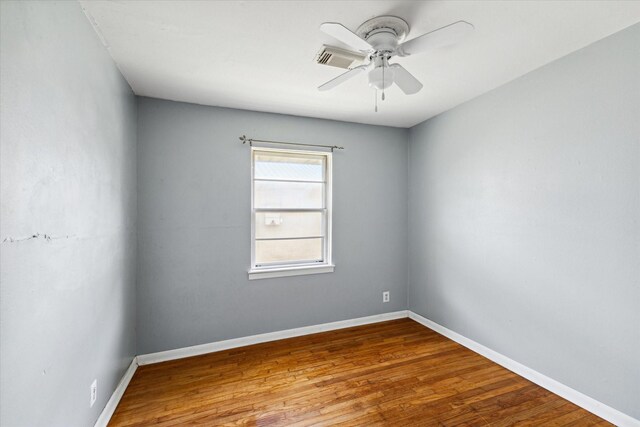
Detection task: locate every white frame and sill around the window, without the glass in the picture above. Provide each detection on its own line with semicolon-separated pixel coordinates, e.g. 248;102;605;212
249;147;335;280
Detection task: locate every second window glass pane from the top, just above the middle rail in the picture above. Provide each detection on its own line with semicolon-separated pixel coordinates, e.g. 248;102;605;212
253;181;324;209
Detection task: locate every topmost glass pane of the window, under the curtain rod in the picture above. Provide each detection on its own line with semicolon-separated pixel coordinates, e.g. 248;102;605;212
253;151;324;182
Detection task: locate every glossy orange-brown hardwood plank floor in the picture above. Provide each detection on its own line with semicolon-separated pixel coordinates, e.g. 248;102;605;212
109;319;611;426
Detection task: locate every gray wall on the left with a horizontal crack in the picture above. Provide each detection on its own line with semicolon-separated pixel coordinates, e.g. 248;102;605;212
0;1;136;427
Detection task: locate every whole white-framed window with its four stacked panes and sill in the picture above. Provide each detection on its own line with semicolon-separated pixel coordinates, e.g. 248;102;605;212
249;147;333;279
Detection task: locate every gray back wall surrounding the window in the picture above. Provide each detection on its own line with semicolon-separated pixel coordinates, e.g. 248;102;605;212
137;98;407;354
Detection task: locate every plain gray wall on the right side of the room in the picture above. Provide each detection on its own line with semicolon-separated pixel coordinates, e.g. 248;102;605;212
409;25;640;418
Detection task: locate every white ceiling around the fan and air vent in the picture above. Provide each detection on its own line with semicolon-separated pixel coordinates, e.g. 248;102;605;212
81;0;640;127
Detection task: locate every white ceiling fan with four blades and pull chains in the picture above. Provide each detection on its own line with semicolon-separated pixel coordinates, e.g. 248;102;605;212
318;16;473;100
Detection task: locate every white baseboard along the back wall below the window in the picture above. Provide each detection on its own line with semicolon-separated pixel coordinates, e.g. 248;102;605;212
138;310;409;365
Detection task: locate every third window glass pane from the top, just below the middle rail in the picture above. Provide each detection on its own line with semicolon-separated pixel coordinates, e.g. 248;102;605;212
255;212;324;239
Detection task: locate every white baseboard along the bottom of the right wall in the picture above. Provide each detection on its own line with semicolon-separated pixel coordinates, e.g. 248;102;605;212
409;311;640;427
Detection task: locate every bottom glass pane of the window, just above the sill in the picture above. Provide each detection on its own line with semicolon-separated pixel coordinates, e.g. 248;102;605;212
256;239;323;265
